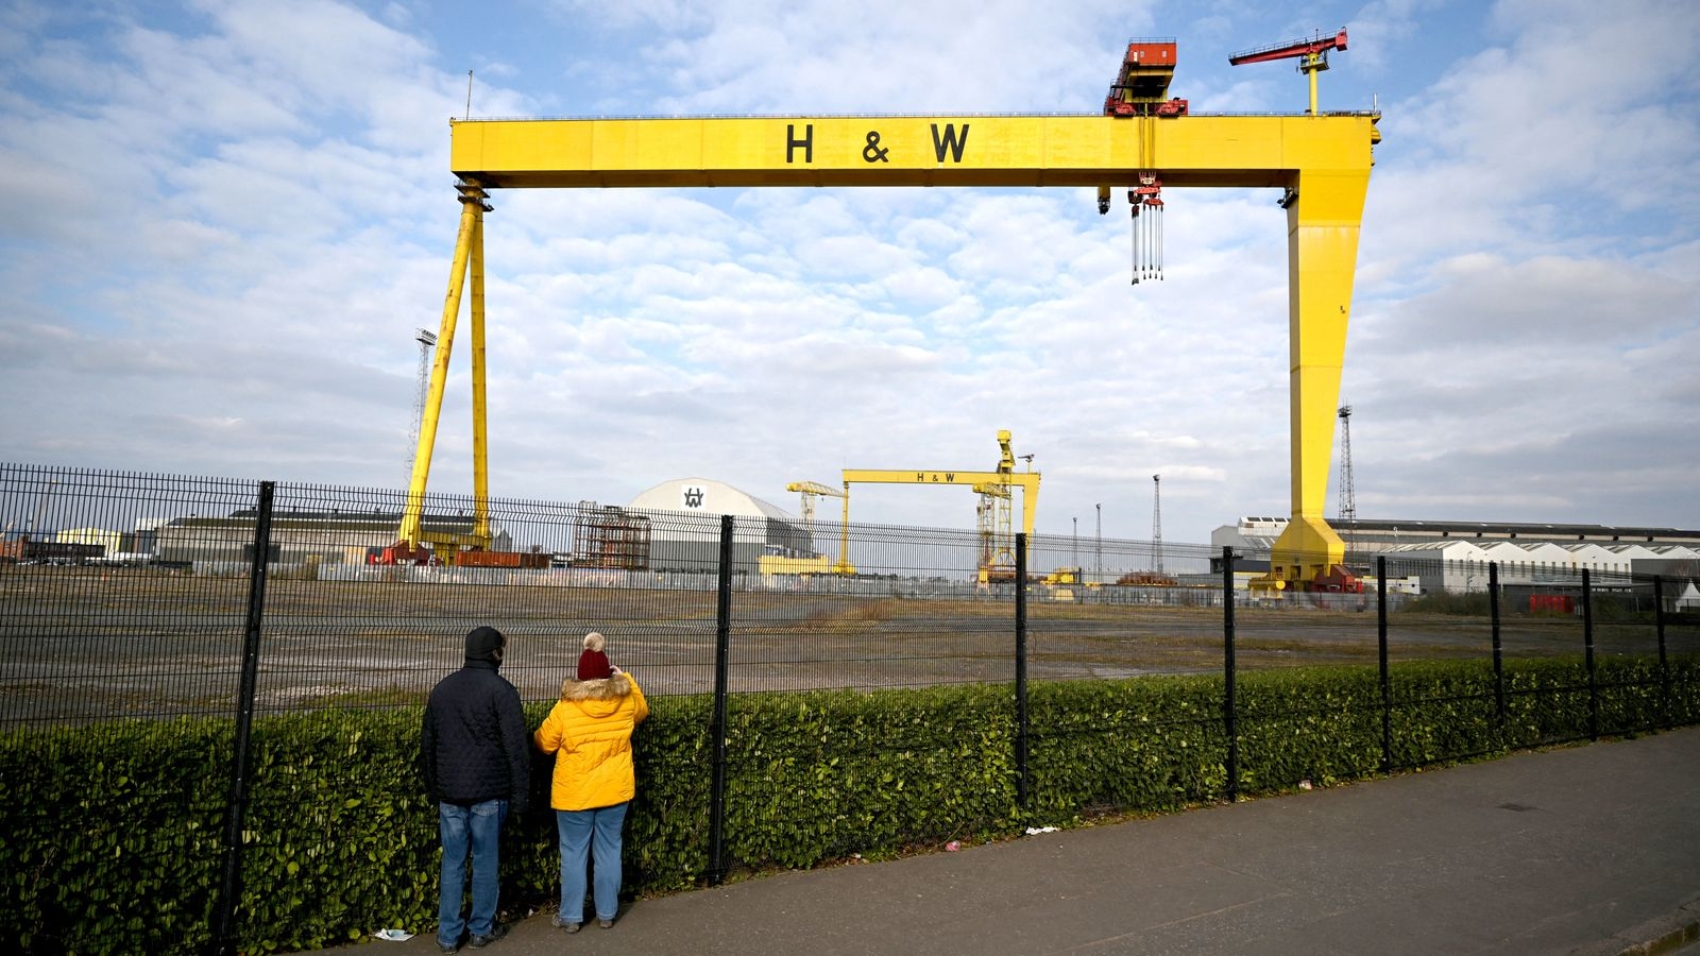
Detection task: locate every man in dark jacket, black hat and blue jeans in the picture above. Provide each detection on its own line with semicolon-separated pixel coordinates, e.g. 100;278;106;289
420;628;530;953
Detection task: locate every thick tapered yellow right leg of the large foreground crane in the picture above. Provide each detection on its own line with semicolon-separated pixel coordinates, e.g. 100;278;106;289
1256;168;1370;587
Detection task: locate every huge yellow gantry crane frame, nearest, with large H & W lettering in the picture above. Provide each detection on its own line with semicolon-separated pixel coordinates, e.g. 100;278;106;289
421;35;1380;587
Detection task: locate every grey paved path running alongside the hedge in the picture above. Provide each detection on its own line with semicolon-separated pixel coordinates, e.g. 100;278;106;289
348;728;1700;956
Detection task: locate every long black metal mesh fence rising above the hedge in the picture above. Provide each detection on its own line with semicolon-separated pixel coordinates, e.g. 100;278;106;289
0;466;1700;939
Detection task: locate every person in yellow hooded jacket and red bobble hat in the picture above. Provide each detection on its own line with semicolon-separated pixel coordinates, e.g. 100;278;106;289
534;631;649;932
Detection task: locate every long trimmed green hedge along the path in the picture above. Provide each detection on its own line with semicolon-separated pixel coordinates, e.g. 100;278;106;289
0;655;1700;953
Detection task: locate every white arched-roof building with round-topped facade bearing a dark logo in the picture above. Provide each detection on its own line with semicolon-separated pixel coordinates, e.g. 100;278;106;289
627;478;814;573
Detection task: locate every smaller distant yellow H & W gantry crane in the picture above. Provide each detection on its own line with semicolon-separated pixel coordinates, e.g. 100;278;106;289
833;429;1039;583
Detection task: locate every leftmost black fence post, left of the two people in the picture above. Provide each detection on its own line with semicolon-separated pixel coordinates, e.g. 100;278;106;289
213;481;277;953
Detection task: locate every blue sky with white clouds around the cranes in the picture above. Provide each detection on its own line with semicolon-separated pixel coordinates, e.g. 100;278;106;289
0;0;1700;541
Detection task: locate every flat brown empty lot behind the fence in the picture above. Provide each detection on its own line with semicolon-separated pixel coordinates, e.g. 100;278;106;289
0;566;1700;714
